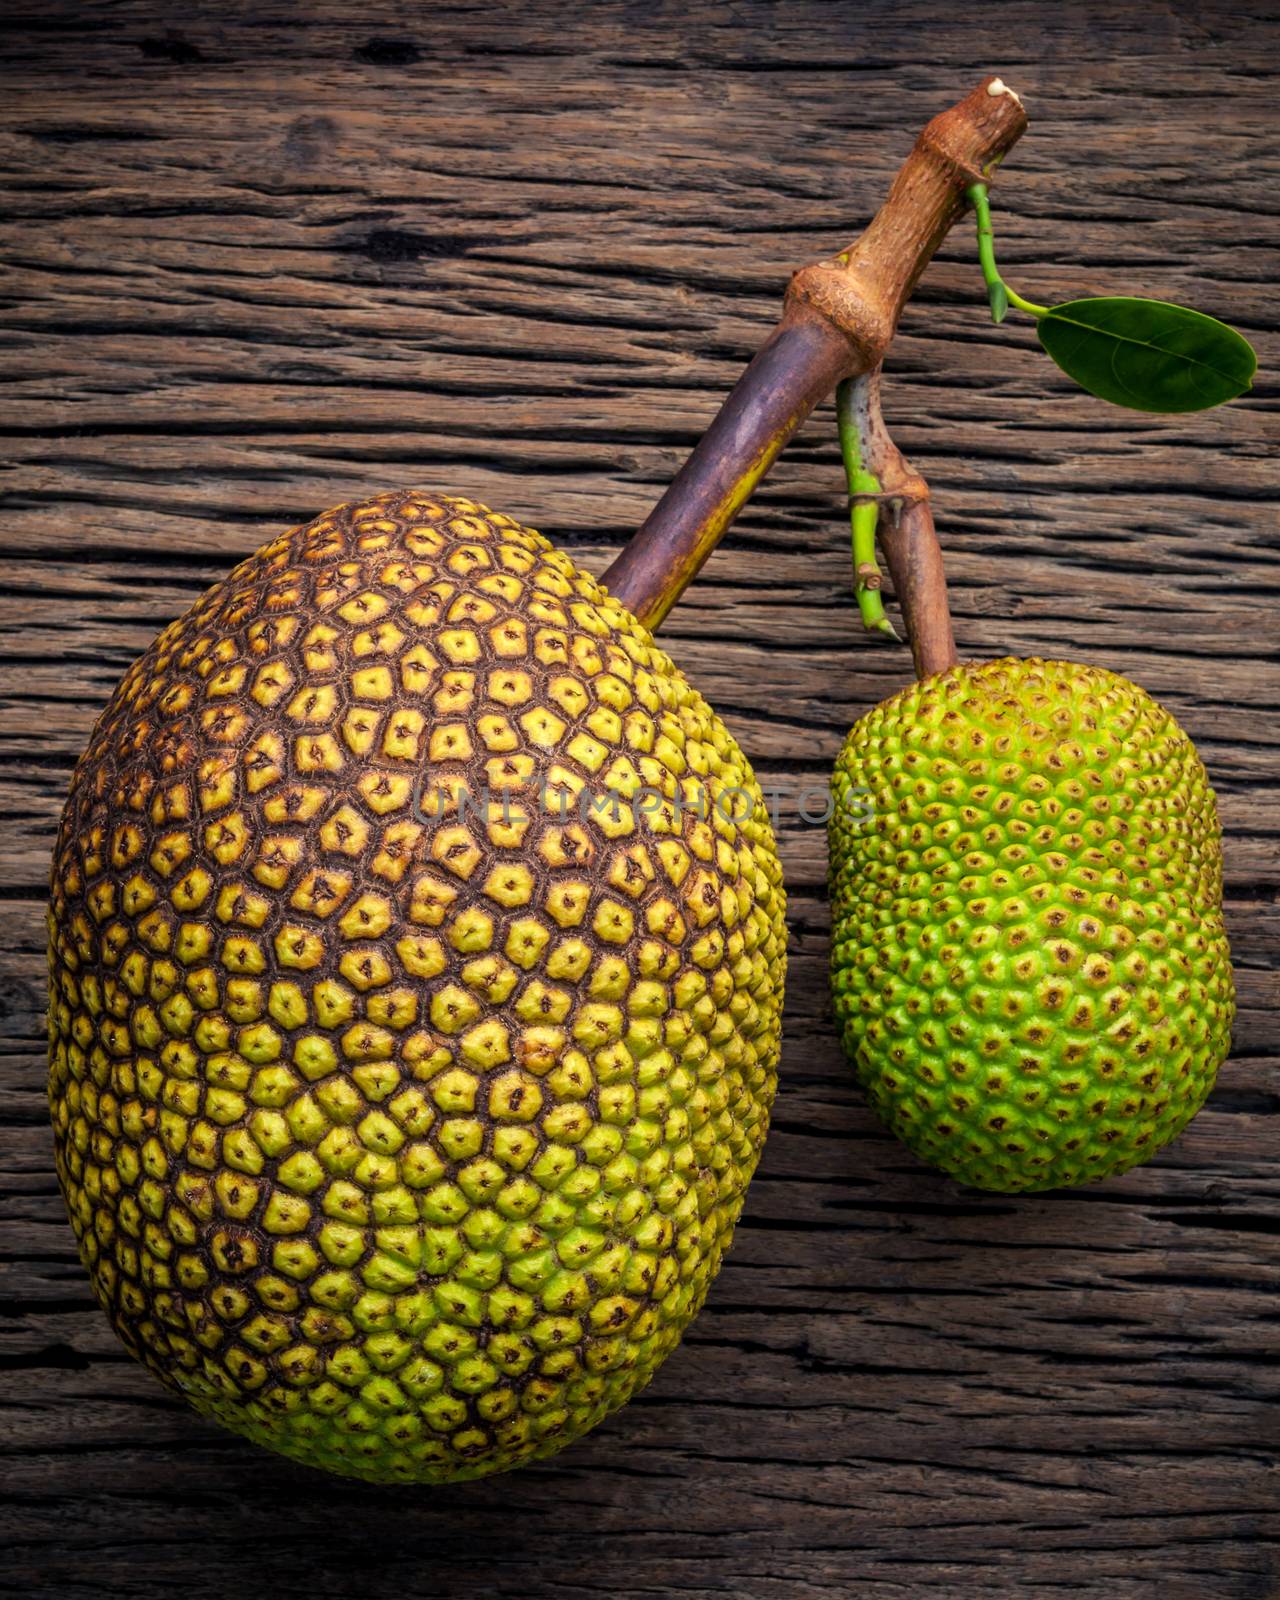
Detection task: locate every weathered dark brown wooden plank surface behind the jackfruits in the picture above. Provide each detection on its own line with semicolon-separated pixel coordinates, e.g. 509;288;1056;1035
0;0;1280;1600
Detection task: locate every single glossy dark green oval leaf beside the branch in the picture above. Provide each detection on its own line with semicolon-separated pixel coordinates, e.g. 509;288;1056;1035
1035;296;1258;411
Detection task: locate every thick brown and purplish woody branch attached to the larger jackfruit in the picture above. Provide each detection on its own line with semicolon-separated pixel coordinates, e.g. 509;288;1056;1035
603;78;1027;627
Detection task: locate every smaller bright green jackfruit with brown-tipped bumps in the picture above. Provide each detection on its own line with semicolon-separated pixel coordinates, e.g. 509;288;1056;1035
830;659;1235;1192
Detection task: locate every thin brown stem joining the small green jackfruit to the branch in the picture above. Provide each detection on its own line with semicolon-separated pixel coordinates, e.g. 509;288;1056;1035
840;366;957;678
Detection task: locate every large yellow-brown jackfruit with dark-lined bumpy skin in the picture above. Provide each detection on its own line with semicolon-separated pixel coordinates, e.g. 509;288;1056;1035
50;491;786;1482
